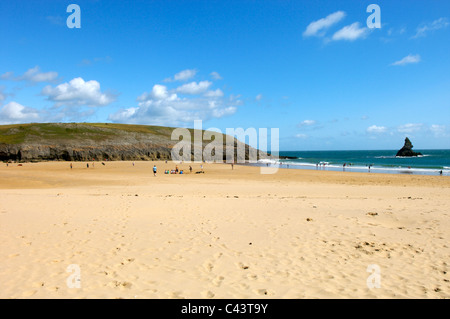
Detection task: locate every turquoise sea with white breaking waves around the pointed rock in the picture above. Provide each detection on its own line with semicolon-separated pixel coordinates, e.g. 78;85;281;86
258;150;450;176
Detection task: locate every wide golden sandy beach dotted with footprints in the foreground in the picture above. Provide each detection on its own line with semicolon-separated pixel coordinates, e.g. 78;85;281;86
0;162;450;299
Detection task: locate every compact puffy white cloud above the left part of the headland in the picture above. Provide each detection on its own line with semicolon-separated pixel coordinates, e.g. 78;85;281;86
41;78;115;106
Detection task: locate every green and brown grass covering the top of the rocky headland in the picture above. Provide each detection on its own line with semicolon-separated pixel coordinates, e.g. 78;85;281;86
0;123;187;145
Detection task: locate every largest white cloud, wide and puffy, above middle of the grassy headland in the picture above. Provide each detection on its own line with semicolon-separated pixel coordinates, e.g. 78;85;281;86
108;81;242;126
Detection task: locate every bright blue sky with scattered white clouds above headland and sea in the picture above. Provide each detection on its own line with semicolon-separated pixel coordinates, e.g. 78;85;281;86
0;0;450;150
